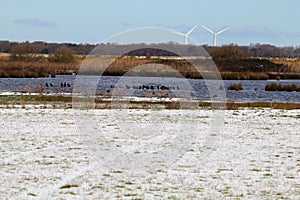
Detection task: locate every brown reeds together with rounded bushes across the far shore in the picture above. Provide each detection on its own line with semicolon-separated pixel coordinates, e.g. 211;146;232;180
0;43;300;80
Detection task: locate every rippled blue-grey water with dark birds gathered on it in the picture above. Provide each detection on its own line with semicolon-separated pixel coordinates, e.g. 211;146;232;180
0;76;300;102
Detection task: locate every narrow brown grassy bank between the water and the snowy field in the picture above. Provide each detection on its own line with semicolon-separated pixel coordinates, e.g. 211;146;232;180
0;95;300;110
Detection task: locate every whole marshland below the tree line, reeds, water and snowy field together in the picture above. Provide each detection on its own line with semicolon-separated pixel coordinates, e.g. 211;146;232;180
0;43;300;199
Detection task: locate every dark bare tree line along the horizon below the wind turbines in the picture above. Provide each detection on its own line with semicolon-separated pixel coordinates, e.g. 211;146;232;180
0;41;300;58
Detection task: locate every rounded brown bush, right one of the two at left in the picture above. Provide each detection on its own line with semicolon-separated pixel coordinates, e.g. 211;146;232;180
49;46;76;63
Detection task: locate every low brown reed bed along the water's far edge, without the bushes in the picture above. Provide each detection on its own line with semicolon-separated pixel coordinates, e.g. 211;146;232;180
0;56;300;80
